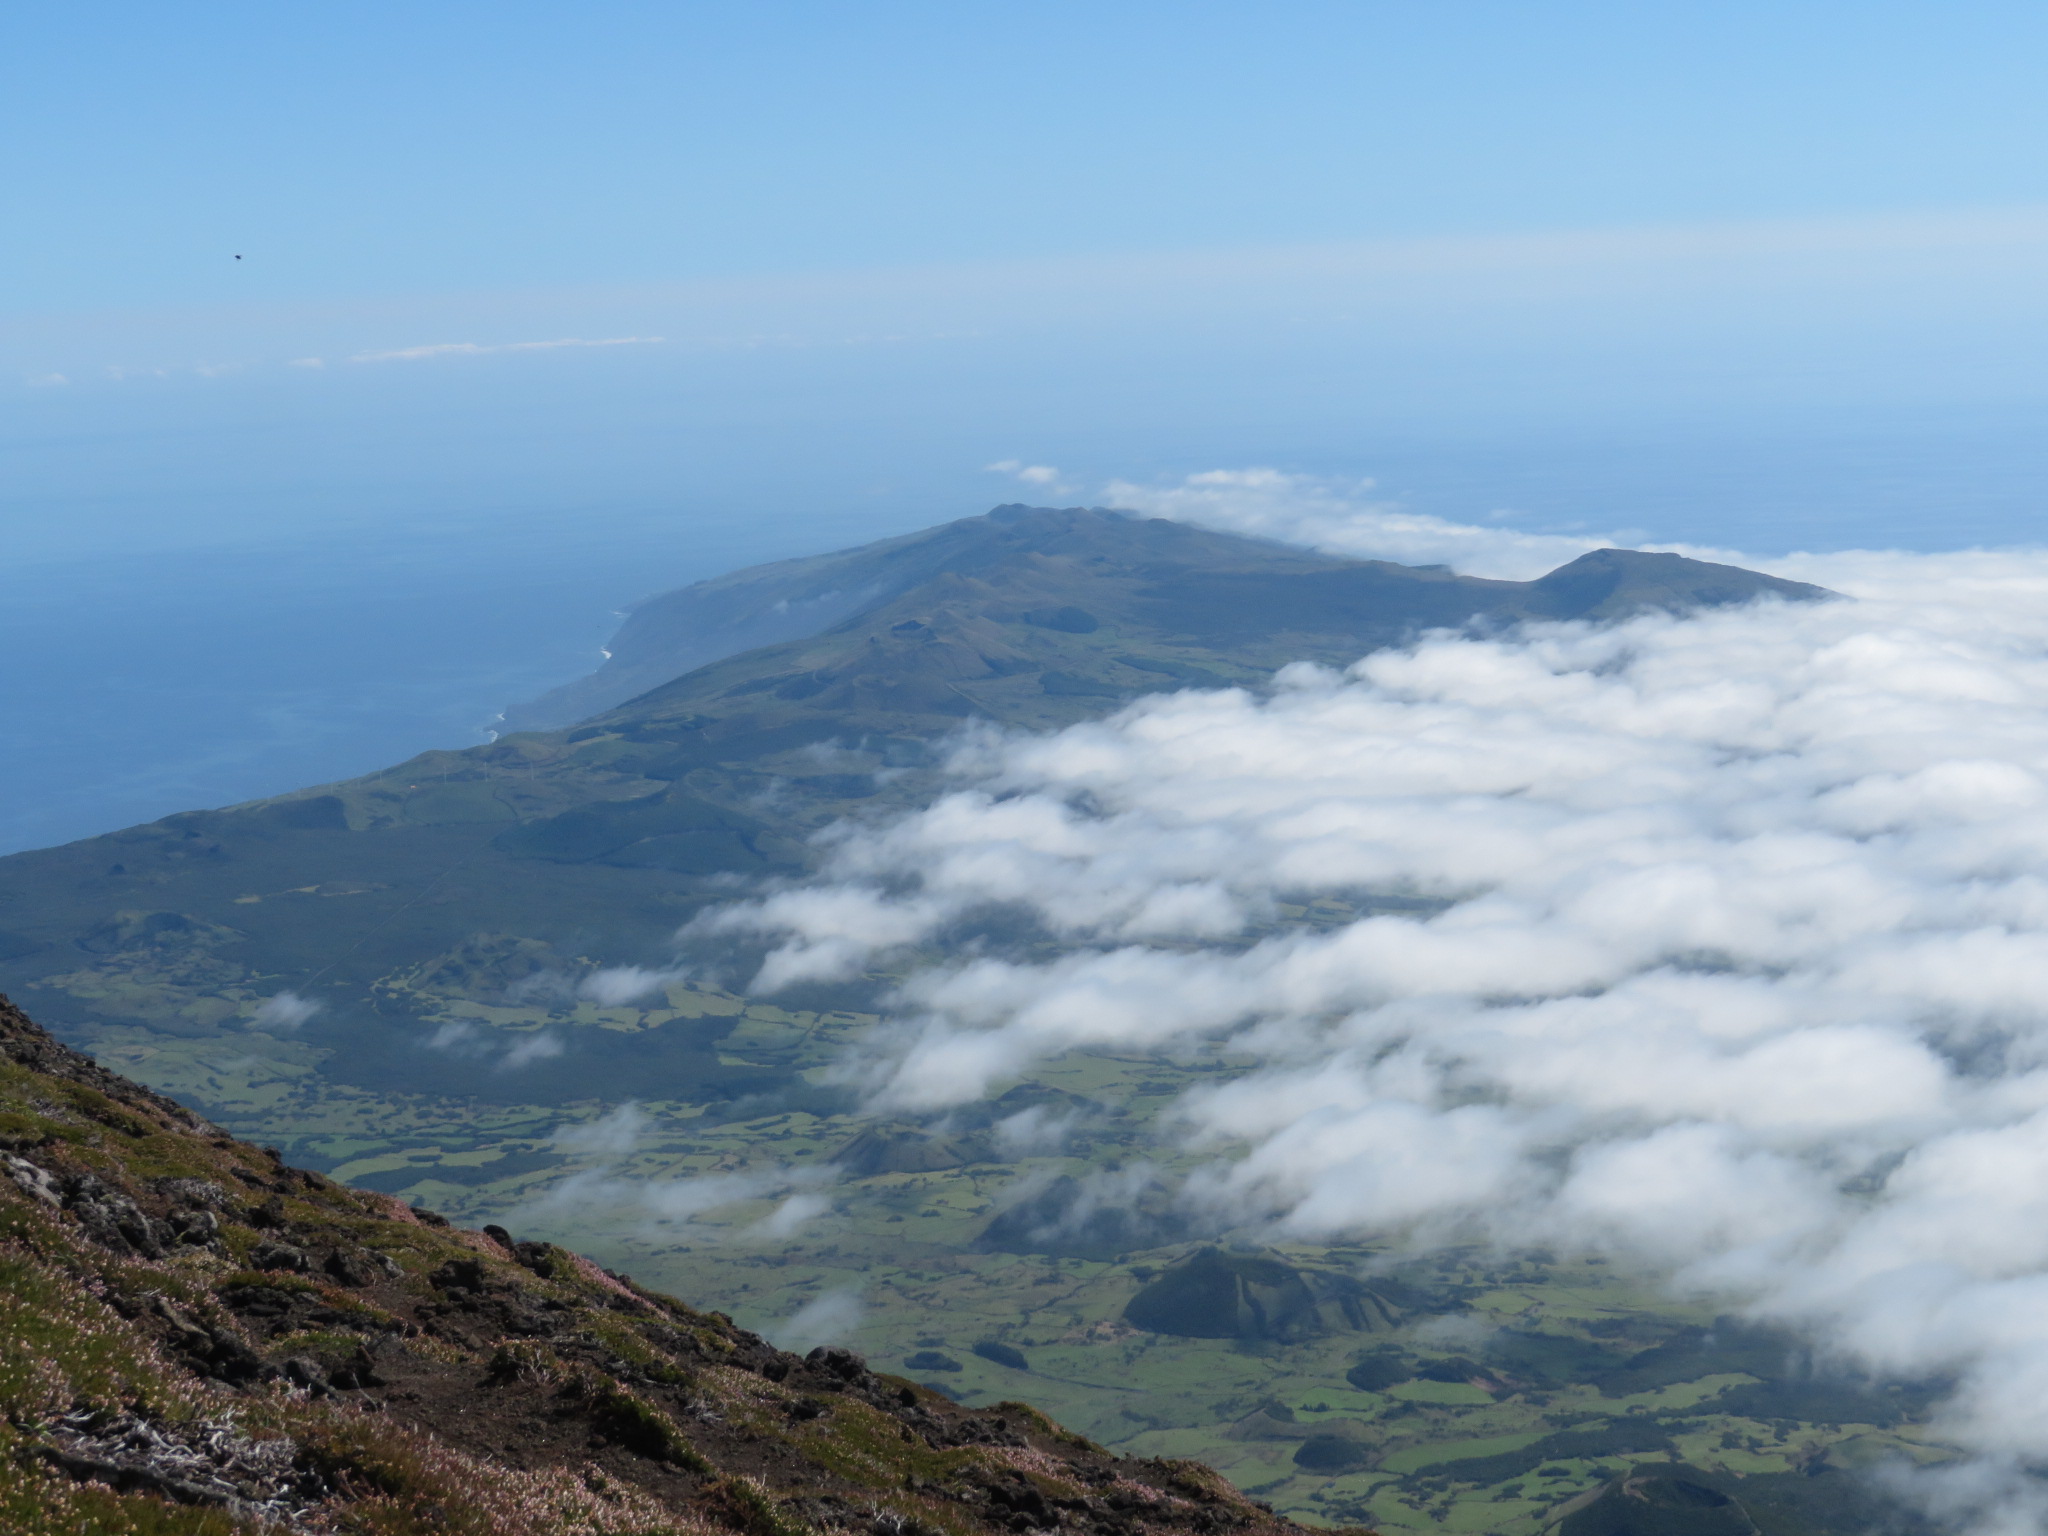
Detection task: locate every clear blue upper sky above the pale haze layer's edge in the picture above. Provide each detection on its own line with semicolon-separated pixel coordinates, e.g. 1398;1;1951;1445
12;0;2048;309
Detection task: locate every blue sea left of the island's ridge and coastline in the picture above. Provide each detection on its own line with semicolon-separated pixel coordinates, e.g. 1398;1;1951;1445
0;518;872;852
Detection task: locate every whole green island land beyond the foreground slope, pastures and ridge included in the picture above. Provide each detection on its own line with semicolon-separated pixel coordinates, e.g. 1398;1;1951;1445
0;508;1884;1536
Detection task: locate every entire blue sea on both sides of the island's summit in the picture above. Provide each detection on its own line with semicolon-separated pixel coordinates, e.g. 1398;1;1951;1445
0;410;2048;850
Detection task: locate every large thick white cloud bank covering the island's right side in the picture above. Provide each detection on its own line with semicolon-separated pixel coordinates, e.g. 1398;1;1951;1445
713;499;2048;1530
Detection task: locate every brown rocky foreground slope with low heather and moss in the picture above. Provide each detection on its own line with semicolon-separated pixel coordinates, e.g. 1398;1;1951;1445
0;997;1300;1536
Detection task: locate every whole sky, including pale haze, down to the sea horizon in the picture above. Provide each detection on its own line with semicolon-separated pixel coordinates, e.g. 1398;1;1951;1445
16;0;2048;493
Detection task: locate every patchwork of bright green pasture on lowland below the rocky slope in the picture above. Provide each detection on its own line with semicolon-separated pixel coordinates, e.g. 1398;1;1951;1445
51;966;1948;1536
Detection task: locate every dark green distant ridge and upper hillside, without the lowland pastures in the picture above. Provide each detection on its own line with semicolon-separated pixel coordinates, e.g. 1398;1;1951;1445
0;508;1819;1081
